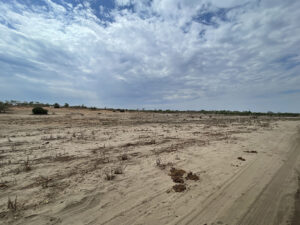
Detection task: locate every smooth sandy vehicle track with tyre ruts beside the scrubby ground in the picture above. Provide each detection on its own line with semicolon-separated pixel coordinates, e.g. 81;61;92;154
175;126;300;225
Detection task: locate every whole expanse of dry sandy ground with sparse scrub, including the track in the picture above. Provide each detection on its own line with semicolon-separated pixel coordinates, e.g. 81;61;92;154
0;108;300;225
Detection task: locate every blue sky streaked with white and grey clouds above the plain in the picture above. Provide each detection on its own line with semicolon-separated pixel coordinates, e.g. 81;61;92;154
0;0;300;112
